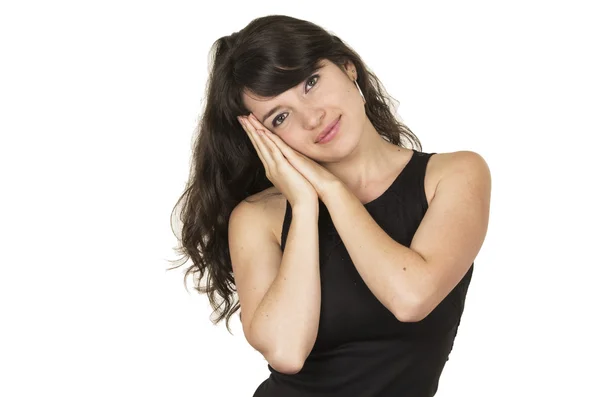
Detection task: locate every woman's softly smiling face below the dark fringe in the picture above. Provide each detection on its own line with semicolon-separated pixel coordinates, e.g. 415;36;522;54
243;60;366;159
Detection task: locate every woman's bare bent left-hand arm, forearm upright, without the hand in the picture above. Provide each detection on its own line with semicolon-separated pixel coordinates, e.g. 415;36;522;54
230;203;321;374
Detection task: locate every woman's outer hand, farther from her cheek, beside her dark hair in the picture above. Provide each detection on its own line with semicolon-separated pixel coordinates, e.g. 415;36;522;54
238;116;318;207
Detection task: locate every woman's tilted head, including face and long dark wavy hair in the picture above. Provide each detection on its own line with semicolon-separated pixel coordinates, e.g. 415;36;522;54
169;15;421;329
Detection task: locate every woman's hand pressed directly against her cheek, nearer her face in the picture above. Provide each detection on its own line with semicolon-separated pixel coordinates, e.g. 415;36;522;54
239;114;339;198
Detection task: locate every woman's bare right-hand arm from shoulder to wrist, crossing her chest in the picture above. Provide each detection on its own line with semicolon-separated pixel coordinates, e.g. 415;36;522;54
323;151;491;322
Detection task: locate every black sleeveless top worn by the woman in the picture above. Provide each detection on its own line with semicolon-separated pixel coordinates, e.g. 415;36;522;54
253;149;474;397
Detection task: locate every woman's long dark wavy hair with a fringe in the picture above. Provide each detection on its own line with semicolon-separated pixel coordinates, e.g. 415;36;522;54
169;15;422;333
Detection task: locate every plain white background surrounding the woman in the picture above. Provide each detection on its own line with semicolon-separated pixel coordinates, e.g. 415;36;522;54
0;1;600;397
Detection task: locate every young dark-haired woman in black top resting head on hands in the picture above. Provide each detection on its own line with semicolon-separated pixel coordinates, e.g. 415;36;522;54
171;16;491;397
